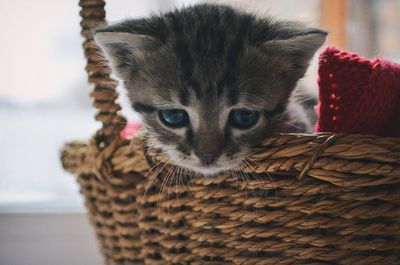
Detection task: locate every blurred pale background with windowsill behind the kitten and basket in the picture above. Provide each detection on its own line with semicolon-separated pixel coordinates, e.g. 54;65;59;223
0;0;400;265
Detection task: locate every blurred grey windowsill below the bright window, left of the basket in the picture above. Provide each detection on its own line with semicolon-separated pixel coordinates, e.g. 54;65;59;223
0;213;102;265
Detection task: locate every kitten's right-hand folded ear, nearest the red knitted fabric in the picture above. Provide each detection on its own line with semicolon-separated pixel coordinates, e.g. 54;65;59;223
261;27;328;72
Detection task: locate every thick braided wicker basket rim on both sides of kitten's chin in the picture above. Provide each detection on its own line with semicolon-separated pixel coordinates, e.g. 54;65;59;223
61;132;400;187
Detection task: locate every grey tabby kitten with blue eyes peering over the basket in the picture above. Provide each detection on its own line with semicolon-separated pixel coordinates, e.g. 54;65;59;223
95;4;327;175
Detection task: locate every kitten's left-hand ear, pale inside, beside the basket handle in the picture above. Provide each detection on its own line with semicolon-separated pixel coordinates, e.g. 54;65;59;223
94;25;162;79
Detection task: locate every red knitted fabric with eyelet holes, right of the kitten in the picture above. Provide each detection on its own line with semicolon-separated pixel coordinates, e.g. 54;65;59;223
316;47;400;137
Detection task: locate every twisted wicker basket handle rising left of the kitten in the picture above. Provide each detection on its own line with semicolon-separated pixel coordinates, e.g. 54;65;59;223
79;0;126;146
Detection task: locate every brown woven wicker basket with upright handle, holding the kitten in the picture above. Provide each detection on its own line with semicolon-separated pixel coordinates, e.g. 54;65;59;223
62;0;400;264
